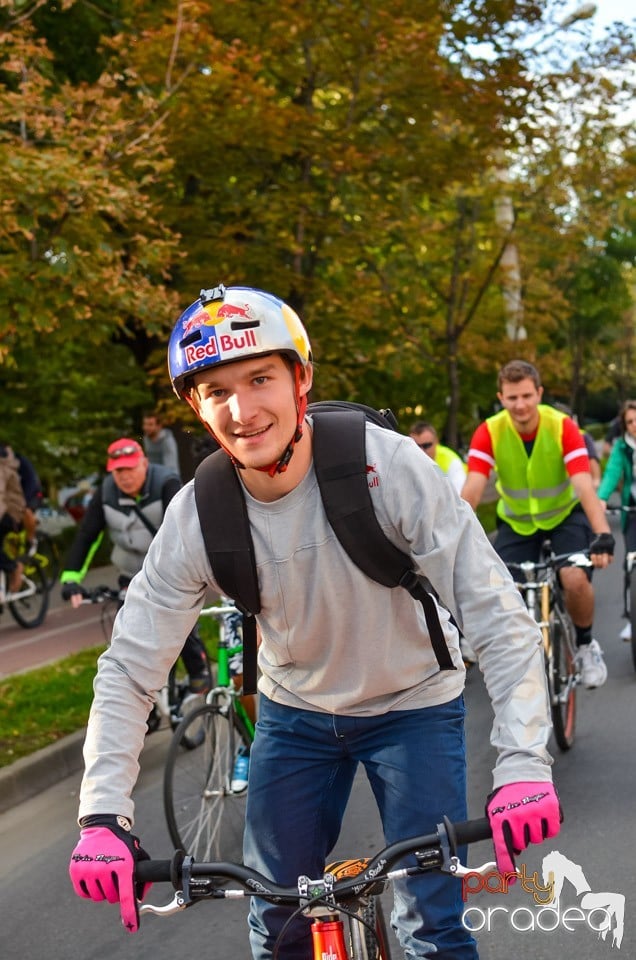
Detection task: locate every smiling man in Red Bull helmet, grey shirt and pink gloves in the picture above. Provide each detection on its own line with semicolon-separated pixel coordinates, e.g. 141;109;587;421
70;287;560;960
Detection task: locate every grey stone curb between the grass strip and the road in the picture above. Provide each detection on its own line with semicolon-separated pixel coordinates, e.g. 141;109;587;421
0;728;86;813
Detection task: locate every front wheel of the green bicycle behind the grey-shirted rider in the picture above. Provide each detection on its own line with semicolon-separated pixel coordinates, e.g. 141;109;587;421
163;703;251;861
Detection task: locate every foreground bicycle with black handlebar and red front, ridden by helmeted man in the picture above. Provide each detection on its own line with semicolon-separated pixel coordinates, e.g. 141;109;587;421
136;817;496;960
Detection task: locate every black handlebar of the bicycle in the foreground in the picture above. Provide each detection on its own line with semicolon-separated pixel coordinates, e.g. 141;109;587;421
135;817;492;903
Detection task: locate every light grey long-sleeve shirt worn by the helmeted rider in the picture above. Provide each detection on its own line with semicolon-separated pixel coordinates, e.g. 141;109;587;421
80;425;551;818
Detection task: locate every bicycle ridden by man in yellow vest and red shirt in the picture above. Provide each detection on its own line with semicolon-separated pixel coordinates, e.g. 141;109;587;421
507;540;593;751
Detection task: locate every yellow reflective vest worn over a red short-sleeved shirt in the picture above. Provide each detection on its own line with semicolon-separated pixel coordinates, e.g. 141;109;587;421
486;404;579;536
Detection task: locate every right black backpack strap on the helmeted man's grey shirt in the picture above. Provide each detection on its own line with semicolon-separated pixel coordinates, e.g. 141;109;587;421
312;409;456;670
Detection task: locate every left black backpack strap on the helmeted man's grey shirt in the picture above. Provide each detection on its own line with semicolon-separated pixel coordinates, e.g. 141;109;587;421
194;450;261;693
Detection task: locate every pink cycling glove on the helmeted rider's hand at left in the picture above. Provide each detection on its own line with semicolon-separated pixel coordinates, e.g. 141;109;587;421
69;814;150;933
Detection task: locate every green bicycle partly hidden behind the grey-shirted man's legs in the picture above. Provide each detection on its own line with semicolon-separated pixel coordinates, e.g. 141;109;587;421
163;598;254;860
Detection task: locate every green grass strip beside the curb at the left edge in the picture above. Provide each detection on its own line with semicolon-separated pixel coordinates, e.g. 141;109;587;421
0;646;104;767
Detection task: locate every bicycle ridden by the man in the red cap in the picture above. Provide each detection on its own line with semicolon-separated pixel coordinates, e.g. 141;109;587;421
80;585;210;750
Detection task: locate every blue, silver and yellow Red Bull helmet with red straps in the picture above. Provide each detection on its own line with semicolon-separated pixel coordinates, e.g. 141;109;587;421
168;284;311;399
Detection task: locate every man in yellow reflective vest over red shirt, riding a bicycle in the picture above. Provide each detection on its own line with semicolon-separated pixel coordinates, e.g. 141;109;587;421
462;360;614;689
